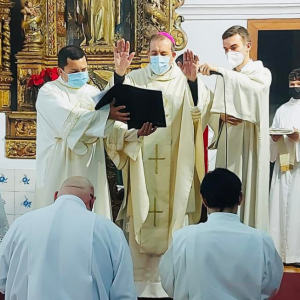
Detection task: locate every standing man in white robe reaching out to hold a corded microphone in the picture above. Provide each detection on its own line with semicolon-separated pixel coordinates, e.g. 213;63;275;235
199;26;272;231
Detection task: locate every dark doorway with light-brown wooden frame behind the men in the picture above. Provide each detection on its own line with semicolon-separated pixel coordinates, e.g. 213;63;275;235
248;19;300;125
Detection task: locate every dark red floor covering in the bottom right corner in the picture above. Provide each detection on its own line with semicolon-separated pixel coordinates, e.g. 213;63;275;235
272;273;300;300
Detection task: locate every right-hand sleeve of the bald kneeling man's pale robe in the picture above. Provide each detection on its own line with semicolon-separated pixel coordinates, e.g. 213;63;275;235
110;230;137;300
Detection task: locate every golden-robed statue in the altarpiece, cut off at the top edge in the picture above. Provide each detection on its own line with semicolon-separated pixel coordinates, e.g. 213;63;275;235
74;0;120;46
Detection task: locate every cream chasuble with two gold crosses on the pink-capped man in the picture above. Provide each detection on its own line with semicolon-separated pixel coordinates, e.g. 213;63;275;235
105;64;204;297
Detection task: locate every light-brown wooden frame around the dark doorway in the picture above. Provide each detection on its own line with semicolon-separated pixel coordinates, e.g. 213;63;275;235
248;19;300;60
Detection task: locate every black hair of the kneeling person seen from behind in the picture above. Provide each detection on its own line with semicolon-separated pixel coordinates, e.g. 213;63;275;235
200;168;242;211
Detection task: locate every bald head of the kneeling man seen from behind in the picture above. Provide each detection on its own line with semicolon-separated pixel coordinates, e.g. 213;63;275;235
54;176;96;210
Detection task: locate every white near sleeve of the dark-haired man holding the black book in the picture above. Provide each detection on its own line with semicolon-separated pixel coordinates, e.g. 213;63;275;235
36;84;114;150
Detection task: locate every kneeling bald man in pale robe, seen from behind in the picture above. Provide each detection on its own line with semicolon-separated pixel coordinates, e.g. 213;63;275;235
0;177;136;300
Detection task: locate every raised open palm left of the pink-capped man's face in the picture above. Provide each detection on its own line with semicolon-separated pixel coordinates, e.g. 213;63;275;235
114;39;135;76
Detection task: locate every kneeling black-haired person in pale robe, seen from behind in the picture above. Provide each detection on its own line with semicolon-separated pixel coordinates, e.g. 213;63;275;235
159;169;283;300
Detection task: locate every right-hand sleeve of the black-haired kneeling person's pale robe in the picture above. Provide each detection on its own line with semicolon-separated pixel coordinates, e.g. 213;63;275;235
261;234;283;299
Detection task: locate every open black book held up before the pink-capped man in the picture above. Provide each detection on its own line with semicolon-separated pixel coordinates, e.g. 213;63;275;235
93;84;166;129
